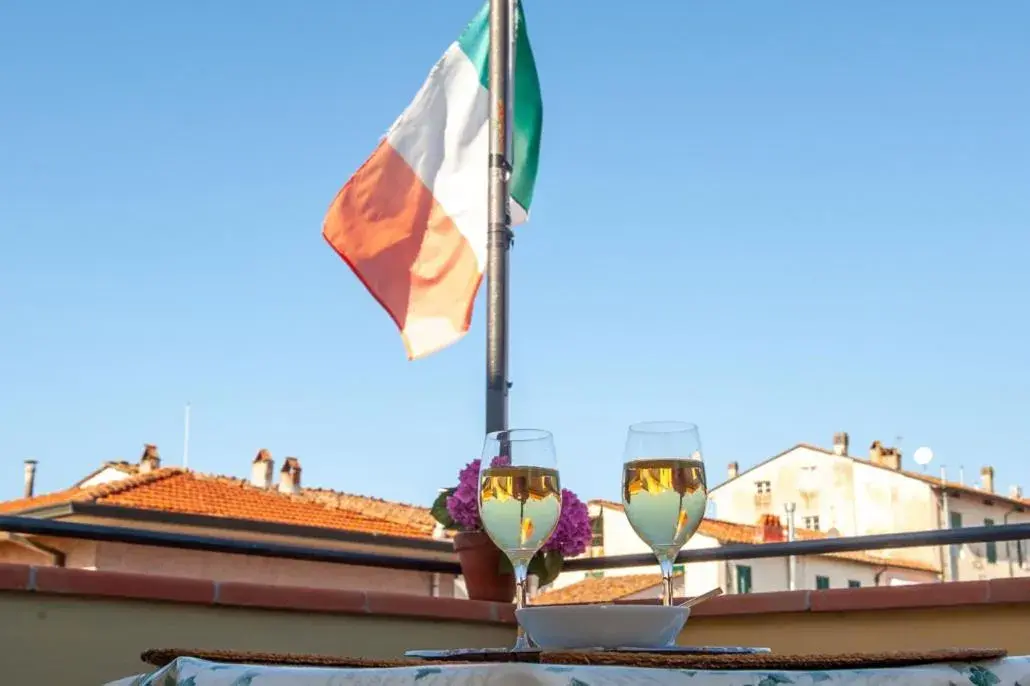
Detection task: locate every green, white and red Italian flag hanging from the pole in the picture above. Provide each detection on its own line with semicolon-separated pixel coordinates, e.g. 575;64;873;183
322;2;543;359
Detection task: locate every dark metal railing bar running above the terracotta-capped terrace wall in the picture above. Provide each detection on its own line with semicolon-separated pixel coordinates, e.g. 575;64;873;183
6;516;1030;575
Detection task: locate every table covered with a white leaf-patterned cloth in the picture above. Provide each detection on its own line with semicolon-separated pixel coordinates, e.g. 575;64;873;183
108;656;1030;686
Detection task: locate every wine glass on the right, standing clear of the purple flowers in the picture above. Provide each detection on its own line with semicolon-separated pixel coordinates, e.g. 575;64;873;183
622;421;708;605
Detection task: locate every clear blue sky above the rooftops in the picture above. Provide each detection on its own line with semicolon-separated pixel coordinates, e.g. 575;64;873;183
0;0;1030;503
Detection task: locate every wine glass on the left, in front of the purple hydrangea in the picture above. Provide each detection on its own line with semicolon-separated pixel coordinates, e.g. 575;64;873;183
479;428;561;650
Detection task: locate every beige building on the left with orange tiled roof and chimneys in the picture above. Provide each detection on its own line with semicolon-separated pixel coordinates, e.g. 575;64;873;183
0;446;460;596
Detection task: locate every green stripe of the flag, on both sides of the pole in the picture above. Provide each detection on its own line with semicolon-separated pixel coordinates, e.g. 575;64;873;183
457;2;544;212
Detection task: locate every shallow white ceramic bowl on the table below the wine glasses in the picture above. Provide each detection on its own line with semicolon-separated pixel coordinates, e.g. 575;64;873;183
515;605;690;650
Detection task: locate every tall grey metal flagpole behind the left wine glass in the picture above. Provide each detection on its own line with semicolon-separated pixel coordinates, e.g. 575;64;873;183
486;0;516;433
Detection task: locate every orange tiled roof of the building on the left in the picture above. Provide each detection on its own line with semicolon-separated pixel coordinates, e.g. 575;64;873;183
0;468;433;539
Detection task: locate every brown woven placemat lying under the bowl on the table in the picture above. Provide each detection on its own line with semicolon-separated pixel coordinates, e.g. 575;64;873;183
140;648;1008;672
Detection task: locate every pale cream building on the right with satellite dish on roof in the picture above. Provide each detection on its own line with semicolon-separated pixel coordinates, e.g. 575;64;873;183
710;433;1030;581
